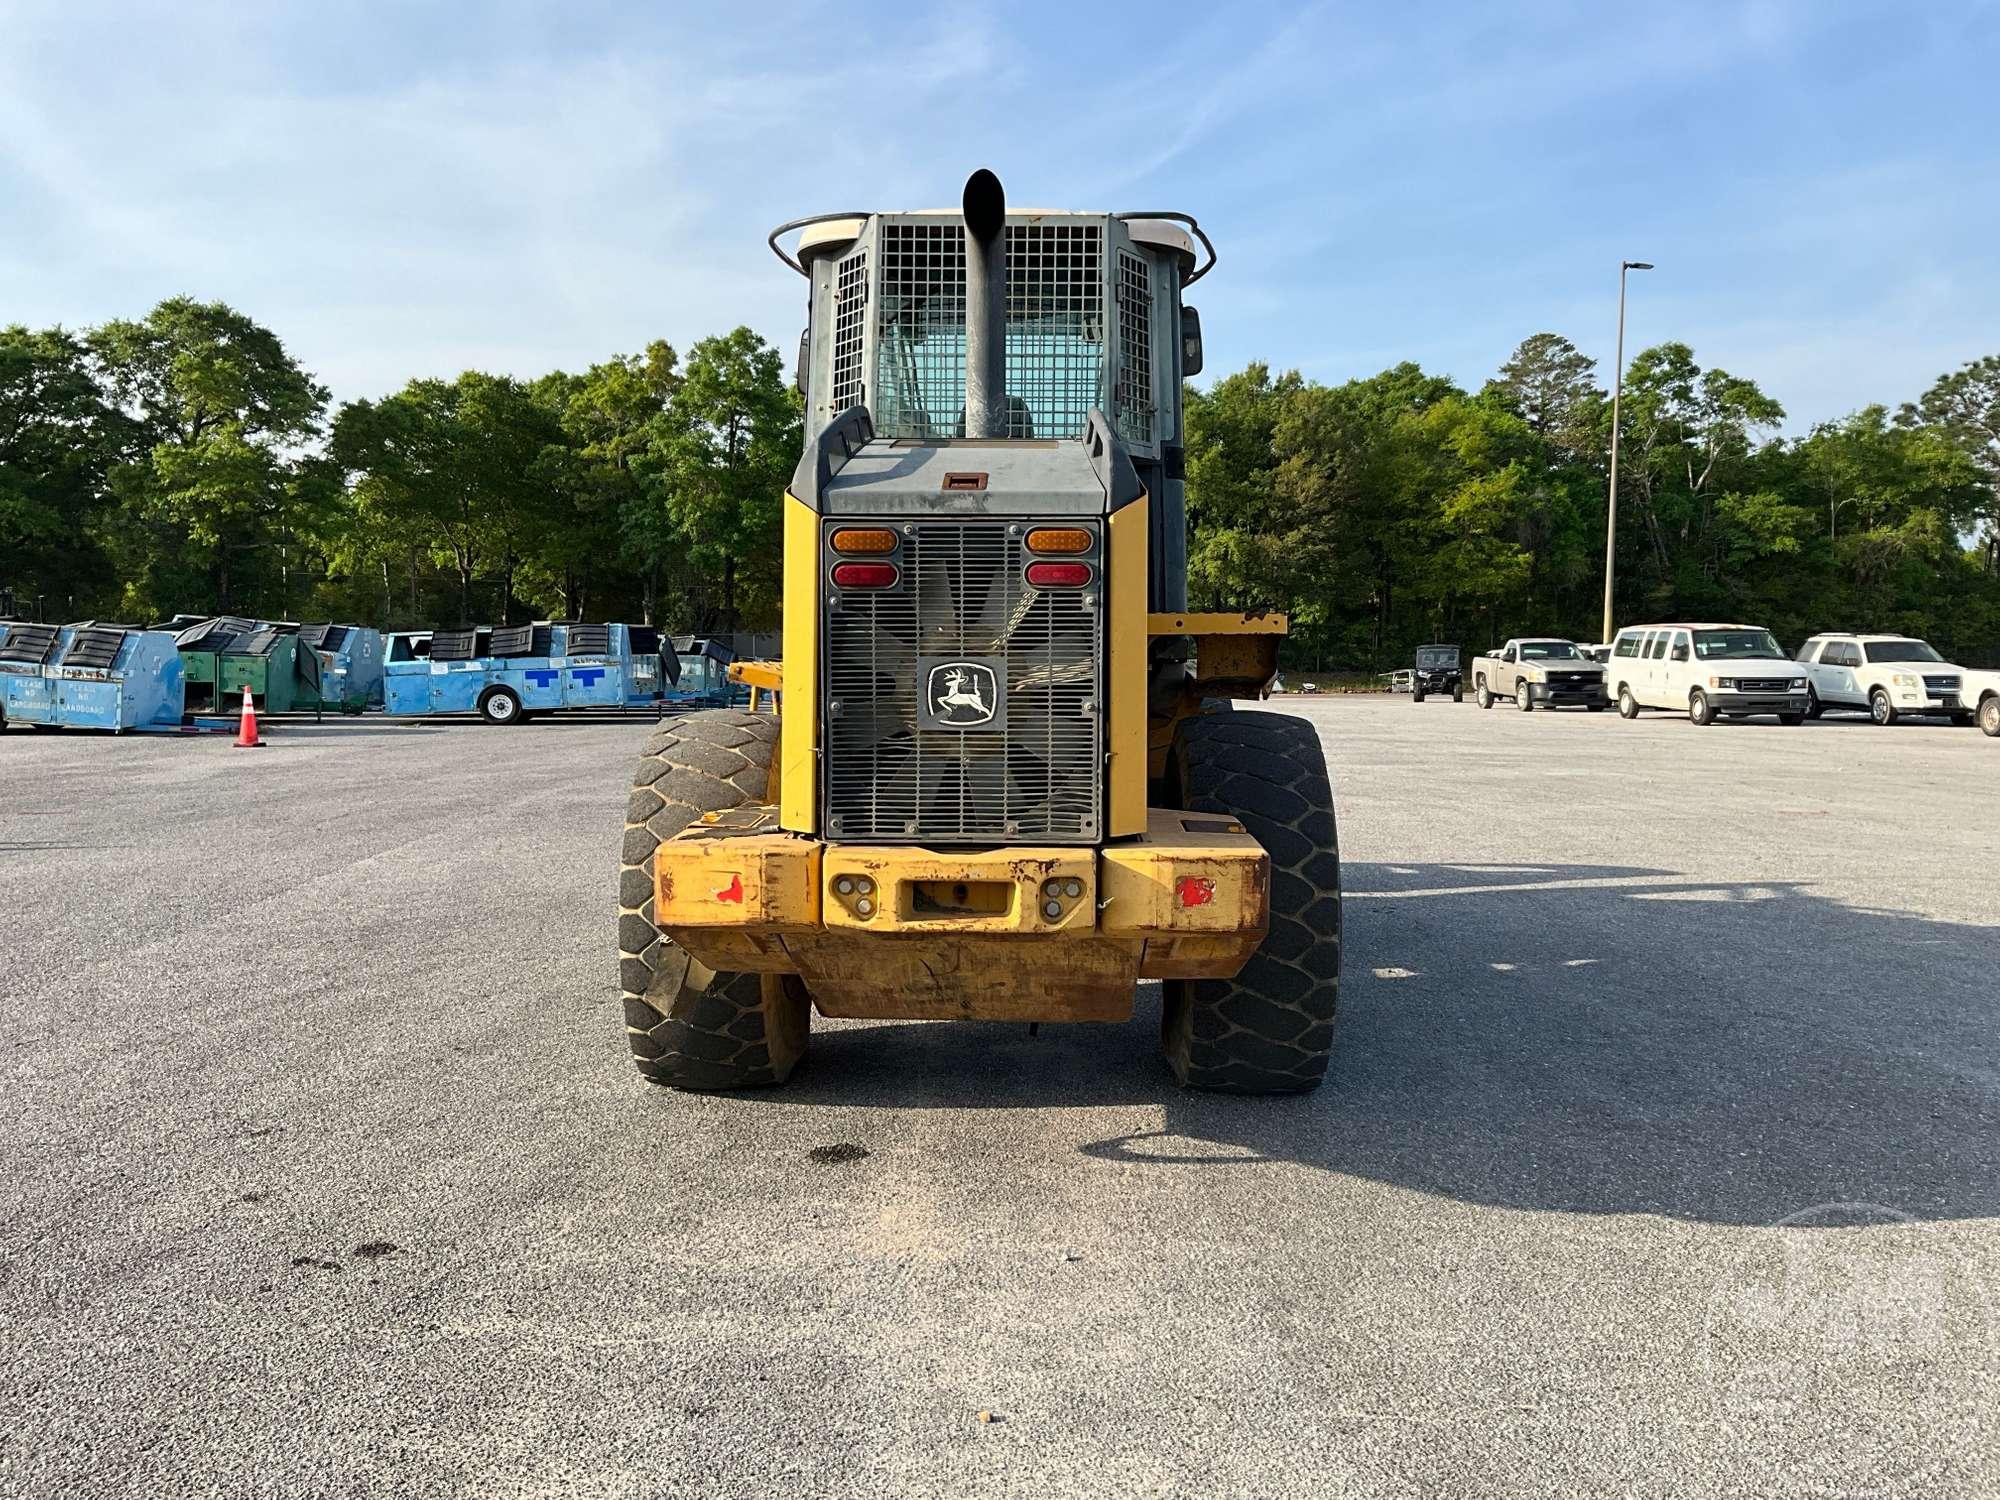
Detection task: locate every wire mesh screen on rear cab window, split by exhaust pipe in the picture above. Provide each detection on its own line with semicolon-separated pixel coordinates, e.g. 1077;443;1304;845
874;220;1104;438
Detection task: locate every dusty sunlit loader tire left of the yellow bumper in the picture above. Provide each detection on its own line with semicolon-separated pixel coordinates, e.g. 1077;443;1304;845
618;708;812;1090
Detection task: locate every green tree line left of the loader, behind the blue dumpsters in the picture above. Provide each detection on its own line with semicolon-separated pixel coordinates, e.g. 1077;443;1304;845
0;298;800;632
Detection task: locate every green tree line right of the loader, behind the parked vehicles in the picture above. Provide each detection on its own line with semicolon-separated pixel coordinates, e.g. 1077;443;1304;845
1188;344;2000;670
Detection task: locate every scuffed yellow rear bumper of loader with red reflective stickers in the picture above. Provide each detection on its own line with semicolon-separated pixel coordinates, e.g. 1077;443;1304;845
654;806;1270;1020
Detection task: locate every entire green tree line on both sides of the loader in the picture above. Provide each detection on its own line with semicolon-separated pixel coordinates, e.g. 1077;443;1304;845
0;298;2000;670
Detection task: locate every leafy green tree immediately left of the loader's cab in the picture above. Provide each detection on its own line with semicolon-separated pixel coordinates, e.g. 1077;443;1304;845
656;328;802;630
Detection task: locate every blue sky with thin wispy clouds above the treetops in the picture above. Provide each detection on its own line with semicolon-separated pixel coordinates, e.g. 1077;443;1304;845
0;0;2000;430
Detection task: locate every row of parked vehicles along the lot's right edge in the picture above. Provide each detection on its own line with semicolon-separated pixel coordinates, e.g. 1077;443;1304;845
1416;622;2000;738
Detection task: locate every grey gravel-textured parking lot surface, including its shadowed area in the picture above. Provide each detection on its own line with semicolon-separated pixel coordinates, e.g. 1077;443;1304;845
0;698;2000;1496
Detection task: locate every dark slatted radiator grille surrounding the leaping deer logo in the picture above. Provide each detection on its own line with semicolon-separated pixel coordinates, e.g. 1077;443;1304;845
824;520;1104;844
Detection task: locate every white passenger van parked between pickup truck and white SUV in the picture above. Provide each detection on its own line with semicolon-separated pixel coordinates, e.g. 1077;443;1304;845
1606;624;1808;724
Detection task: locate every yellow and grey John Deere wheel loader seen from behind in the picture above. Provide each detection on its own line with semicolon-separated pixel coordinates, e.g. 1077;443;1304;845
618;172;1340;1094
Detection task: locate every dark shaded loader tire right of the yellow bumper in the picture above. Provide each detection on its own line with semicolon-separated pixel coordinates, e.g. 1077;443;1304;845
1160;714;1340;1094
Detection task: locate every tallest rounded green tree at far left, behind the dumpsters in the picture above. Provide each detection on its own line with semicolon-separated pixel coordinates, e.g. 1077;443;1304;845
88;296;326;612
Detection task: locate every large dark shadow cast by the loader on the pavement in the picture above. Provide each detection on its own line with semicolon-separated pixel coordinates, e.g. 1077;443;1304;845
772;864;2000;1224
